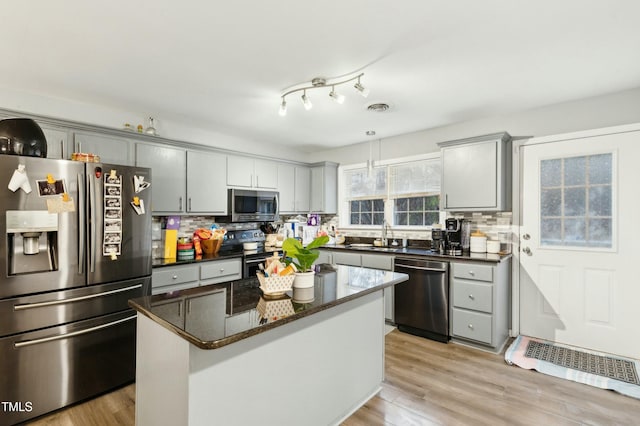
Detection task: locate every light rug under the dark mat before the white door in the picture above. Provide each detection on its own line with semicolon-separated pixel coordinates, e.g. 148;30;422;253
504;336;640;399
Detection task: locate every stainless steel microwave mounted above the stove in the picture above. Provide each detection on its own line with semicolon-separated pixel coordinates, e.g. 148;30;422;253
229;189;278;222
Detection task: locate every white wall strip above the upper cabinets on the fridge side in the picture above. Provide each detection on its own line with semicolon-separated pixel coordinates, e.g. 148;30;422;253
0;87;309;162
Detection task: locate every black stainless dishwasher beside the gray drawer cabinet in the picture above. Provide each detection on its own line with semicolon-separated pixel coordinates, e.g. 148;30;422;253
394;257;449;343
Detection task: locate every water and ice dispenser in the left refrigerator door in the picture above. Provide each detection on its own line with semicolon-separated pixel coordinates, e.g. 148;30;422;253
7;210;58;275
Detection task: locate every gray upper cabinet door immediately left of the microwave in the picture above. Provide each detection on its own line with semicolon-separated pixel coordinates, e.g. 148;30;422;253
186;151;227;215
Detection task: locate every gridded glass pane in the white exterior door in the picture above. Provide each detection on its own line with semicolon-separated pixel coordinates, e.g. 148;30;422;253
540;154;613;248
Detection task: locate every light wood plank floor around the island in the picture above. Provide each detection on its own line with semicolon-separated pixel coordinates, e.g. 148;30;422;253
31;330;640;426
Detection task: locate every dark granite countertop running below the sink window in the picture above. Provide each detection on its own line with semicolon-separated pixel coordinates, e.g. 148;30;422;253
322;244;512;263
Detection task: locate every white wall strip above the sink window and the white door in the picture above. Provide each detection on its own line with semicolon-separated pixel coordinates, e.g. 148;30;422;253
313;88;640;164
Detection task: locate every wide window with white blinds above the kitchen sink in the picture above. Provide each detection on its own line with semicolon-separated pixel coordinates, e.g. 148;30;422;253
341;155;440;227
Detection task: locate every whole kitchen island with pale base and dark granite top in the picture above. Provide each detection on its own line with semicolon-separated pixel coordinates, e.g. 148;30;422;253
129;264;407;425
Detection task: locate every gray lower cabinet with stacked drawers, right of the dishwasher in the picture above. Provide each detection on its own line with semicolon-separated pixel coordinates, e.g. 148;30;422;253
449;259;511;352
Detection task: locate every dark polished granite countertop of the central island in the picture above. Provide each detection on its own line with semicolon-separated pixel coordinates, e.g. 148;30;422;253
129;264;408;349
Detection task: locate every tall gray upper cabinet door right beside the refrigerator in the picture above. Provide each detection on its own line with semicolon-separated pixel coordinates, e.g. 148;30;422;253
136;143;187;213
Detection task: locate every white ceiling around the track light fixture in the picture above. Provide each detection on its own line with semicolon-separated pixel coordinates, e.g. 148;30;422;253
0;0;640;151
